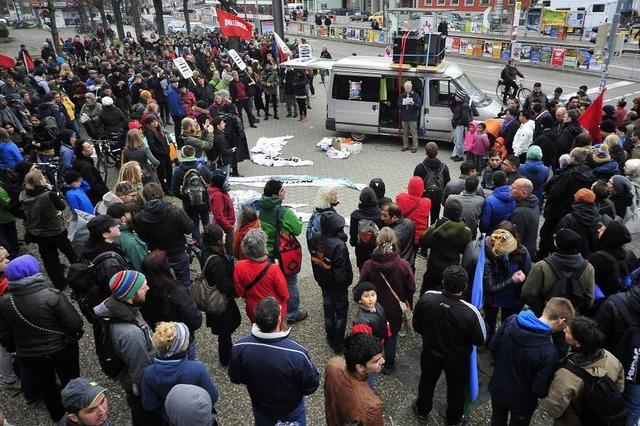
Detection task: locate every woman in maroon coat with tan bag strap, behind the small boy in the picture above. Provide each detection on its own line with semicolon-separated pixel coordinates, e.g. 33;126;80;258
359;226;416;374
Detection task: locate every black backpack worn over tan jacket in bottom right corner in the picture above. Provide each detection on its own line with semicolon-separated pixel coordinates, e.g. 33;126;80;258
561;362;628;426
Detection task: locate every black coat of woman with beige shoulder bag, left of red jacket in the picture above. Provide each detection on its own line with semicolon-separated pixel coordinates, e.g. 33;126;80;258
200;248;242;335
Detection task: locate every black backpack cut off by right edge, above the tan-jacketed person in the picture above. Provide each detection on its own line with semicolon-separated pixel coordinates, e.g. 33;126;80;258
610;293;640;385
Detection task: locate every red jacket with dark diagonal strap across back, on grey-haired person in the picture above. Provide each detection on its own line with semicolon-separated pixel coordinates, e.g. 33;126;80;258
233;259;289;323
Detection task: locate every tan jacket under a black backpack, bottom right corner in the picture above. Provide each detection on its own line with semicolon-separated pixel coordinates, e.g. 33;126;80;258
542;349;624;426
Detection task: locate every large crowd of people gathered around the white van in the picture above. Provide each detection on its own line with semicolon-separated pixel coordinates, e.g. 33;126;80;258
0;25;640;426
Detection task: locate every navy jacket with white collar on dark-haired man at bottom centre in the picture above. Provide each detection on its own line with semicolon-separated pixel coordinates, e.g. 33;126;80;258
229;324;320;416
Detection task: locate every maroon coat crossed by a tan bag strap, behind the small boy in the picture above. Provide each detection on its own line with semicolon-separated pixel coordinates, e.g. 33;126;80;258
359;249;416;334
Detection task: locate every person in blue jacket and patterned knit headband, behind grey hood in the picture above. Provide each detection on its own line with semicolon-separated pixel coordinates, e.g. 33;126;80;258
142;322;218;423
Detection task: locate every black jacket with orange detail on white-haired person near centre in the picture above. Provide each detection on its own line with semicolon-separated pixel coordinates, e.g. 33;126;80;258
309;210;353;289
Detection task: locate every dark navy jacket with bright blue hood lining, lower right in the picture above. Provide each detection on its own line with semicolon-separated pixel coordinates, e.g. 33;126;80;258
489;311;559;414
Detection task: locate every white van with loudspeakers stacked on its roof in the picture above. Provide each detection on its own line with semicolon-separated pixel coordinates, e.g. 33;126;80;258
281;56;501;141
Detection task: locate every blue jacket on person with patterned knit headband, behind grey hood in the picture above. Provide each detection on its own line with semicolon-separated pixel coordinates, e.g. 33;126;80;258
142;358;218;420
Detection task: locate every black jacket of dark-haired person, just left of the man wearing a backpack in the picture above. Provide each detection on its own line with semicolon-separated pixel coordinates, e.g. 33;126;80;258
133;198;193;256
